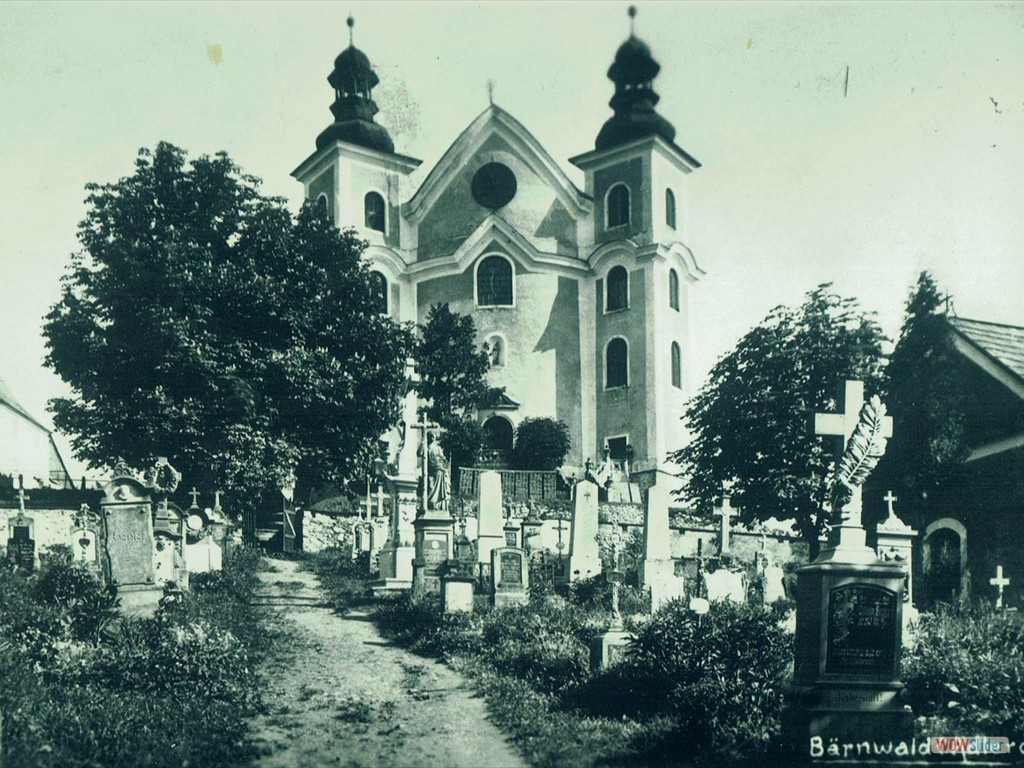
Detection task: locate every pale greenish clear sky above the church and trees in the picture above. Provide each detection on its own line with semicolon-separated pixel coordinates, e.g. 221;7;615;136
0;1;1024;474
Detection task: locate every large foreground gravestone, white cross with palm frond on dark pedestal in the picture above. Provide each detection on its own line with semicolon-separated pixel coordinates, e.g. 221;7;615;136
782;382;913;755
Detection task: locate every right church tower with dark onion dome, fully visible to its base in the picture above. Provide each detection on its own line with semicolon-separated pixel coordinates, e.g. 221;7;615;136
569;7;702;471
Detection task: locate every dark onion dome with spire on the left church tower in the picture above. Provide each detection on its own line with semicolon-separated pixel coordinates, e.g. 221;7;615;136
316;16;394;153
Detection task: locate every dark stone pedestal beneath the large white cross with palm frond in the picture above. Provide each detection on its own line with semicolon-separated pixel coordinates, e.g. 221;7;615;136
782;553;913;755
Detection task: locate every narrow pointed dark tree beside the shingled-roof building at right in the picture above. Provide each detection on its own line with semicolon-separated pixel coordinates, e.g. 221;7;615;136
879;271;970;511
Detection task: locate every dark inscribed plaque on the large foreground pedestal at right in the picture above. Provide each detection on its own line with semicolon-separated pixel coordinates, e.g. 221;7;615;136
825;584;896;675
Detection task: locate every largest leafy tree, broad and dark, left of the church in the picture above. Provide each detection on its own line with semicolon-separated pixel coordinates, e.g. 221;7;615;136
44;143;412;507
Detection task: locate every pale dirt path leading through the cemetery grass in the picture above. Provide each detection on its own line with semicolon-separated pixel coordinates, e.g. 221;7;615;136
244;560;525;768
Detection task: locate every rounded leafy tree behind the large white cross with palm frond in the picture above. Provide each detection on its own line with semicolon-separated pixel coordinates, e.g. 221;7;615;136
672;284;883;556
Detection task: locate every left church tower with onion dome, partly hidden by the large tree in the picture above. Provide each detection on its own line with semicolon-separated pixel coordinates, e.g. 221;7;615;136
292;16;420;319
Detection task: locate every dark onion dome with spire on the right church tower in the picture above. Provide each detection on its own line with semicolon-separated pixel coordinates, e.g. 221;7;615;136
594;6;676;150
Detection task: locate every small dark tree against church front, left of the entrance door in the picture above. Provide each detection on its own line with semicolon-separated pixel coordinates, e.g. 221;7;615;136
414;304;504;468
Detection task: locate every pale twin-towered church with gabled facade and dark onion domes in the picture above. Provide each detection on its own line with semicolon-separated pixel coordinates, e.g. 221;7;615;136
293;18;703;479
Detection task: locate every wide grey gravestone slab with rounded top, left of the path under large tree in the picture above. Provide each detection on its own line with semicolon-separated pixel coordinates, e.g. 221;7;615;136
99;468;163;613
